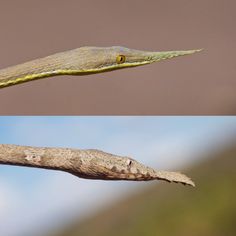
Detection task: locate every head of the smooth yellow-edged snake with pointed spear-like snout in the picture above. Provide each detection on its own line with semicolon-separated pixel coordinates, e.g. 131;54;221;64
71;46;201;74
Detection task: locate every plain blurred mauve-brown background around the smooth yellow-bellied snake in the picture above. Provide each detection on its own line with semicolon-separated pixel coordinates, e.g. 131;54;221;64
0;0;236;115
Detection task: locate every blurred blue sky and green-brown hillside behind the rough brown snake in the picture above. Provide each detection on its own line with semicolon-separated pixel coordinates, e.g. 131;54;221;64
0;117;236;236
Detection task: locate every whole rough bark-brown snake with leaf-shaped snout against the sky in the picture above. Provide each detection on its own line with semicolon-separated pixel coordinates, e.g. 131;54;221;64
0;144;195;186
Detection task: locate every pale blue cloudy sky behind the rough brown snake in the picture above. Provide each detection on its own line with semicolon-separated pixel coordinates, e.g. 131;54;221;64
0;116;236;236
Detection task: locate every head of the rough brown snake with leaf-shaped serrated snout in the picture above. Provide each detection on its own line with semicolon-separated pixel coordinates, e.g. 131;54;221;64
70;149;194;186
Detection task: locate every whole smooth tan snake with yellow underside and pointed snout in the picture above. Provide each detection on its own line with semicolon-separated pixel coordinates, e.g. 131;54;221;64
0;46;201;88
